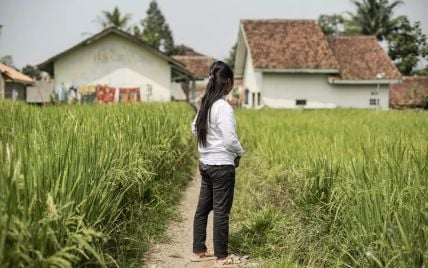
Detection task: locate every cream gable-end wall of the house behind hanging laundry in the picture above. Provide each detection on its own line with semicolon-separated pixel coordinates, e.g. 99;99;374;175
54;34;171;101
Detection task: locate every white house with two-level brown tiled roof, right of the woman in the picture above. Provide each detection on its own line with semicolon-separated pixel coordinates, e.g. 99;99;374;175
235;19;401;108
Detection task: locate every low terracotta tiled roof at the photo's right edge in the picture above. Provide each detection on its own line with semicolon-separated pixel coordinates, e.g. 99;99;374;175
389;76;428;108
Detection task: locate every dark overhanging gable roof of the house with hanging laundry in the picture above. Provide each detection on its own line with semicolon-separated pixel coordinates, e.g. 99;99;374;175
37;26;190;75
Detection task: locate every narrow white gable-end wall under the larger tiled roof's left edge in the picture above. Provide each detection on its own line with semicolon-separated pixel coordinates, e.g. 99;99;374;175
243;53;263;107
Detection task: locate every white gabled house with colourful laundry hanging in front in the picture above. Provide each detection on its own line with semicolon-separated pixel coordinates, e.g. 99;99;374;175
38;27;192;101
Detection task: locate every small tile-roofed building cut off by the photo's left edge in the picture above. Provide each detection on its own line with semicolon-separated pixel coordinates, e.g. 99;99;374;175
0;63;34;101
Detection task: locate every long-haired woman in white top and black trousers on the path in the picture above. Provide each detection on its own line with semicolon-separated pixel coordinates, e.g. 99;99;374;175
192;61;244;267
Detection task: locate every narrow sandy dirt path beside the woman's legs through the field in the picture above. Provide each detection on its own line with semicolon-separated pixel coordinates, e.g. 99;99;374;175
143;171;214;268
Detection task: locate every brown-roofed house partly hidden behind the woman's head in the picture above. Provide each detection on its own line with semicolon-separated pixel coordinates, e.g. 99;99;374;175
172;47;214;106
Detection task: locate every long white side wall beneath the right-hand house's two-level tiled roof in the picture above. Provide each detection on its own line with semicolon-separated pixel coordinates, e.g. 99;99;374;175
261;73;389;109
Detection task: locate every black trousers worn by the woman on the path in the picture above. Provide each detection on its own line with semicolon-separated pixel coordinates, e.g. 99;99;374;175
193;163;235;258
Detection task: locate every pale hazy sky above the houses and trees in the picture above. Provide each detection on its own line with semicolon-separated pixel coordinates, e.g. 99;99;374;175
0;0;428;68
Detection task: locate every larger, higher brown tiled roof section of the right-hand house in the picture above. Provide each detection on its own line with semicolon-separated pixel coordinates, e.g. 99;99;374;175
241;19;338;72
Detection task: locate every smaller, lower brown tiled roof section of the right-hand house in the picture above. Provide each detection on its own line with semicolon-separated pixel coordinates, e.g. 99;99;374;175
328;36;401;80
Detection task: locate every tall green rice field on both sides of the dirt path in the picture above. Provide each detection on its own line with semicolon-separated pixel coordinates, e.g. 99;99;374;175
0;102;428;267
